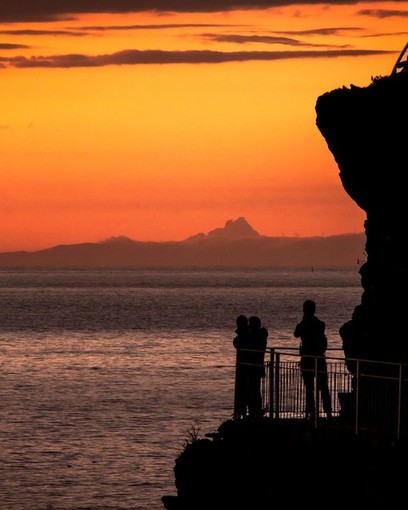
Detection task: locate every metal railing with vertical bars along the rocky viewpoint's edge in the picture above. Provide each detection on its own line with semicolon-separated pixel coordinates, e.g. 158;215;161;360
234;347;408;439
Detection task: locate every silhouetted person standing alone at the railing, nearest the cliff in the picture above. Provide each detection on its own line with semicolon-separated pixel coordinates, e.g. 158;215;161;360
293;299;332;419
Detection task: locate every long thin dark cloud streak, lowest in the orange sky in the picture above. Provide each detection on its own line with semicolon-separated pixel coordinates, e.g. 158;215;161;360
0;49;393;68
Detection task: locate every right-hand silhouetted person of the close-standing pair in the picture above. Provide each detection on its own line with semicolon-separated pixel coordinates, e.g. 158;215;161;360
248;315;268;418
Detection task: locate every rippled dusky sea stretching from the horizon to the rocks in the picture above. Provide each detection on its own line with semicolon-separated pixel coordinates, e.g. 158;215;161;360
0;266;362;510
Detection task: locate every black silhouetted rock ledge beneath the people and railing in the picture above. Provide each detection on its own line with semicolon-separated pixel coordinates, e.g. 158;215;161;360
162;418;408;510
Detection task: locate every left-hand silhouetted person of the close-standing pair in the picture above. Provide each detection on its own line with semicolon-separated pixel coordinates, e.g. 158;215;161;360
232;315;250;419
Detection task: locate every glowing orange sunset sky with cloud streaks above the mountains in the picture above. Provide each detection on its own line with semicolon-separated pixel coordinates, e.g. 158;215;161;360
0;0;408;251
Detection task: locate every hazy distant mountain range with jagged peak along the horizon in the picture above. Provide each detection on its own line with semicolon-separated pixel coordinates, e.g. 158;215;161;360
0;217;366;268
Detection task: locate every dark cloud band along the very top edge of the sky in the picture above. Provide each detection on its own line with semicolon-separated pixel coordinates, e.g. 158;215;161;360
0;0;404;22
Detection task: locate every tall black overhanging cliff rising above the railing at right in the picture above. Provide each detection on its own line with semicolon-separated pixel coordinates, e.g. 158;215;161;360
316;68;408;363
